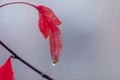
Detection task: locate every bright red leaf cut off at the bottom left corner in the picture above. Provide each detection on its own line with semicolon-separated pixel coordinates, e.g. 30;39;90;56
0;57;15;80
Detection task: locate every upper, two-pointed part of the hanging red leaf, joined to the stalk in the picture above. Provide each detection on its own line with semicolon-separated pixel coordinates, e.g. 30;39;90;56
36;6;61;39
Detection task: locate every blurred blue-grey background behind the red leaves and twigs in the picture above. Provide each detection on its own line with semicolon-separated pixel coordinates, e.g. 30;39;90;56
0;0;120;80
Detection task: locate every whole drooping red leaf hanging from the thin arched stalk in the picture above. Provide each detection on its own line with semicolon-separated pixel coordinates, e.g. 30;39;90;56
36;6;62;64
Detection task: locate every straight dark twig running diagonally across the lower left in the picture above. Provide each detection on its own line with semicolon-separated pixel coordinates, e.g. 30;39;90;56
0;40;54;80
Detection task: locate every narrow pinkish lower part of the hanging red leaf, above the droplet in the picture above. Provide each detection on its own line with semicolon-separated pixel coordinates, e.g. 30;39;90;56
49;24;62;64
